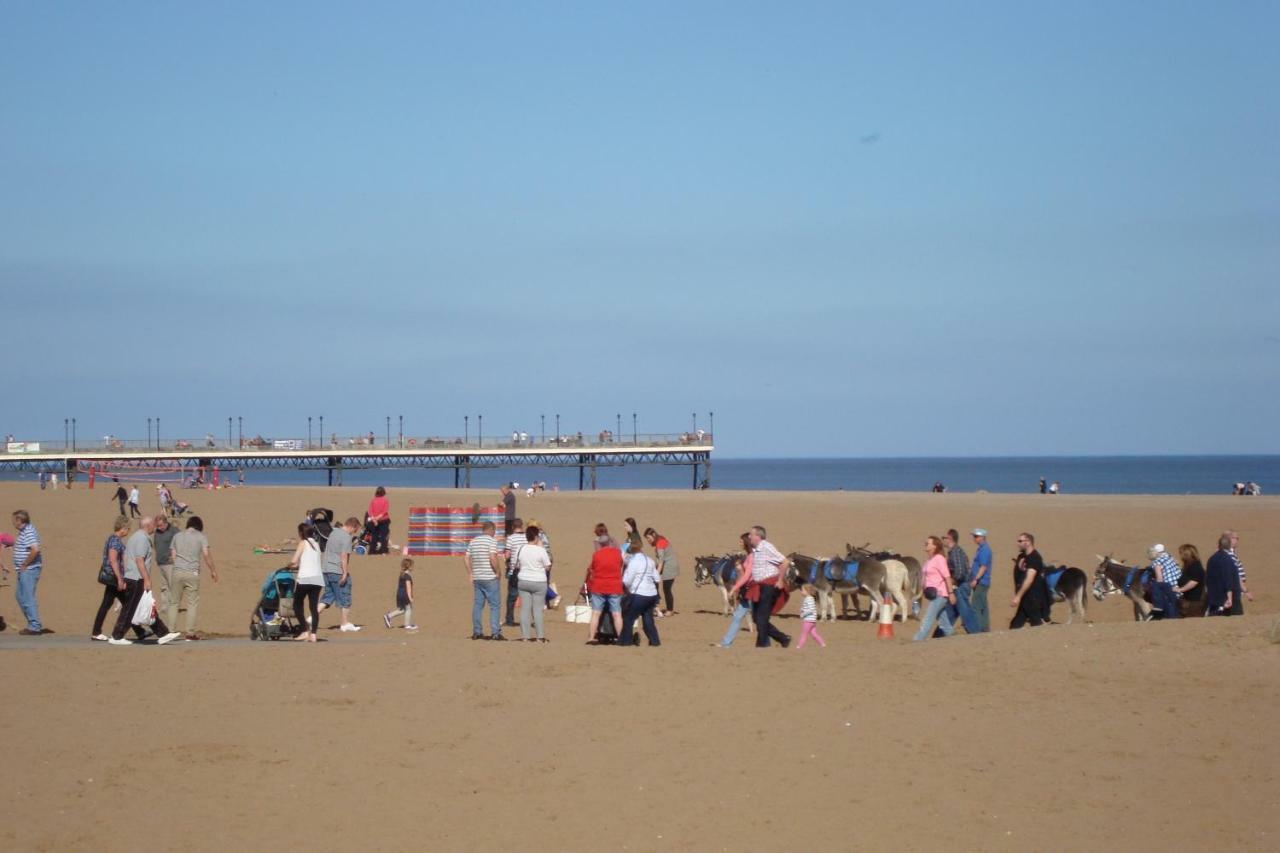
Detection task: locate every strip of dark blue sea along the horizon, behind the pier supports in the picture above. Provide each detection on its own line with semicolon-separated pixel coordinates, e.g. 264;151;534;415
5;456;1280;494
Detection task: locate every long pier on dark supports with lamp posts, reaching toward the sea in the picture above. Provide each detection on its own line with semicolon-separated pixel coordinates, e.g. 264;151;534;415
0;430;714;491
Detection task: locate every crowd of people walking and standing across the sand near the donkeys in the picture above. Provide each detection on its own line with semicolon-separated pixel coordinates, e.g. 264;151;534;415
0;484;1252;648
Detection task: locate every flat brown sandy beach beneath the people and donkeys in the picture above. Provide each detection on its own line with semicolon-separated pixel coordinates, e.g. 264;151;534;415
0;484;1280;850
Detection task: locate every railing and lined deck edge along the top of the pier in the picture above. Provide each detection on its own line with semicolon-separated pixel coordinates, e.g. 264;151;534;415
0;430;712;459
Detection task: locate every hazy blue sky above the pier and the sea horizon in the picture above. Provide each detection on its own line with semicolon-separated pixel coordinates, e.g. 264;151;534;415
0;0;1280;456
